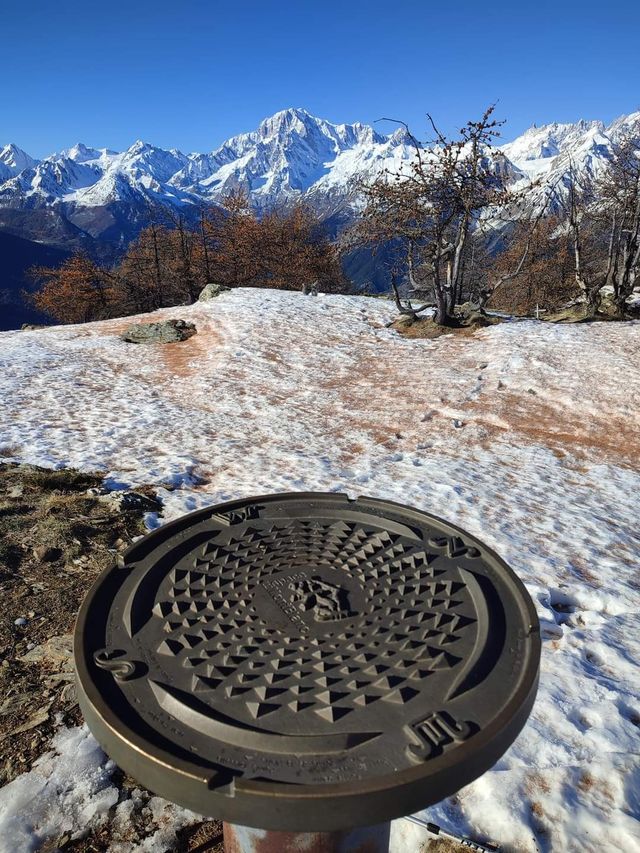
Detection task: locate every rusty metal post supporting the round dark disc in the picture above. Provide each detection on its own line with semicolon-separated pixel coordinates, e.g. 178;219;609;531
224;822;391;853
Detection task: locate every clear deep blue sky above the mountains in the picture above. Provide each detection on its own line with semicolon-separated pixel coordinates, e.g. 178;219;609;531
0;0;640;156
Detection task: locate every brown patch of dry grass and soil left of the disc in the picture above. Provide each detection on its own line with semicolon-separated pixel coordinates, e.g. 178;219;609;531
0;464;155;784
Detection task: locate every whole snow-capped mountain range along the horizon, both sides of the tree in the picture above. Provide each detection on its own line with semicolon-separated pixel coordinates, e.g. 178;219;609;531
0;109;640;251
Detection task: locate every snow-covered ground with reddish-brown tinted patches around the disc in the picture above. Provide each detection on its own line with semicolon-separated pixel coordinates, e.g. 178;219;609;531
0;289;640;853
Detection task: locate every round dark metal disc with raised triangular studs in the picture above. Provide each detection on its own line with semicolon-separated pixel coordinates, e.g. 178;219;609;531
75;493;540;831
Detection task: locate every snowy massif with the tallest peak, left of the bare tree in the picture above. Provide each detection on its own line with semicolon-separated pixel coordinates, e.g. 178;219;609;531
0;109;413;221
